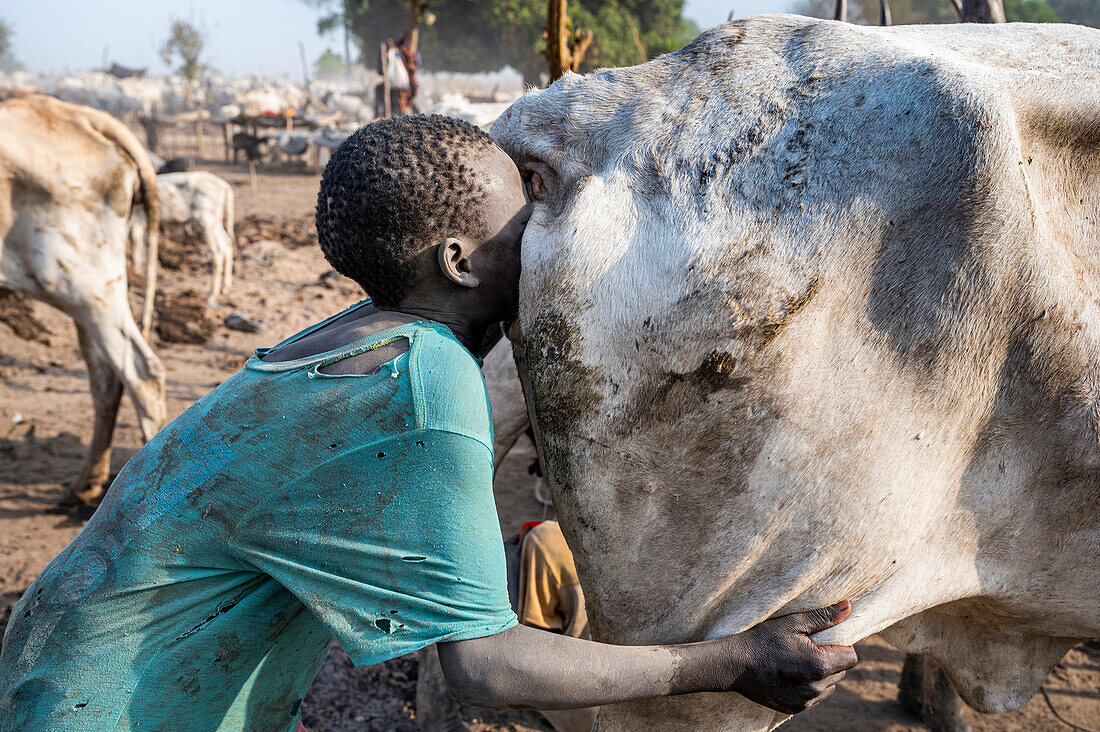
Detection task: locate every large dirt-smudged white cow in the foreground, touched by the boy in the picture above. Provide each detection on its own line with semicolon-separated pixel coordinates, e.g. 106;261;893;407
493;15;1100;730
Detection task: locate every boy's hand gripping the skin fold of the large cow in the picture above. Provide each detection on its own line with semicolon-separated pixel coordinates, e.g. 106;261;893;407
728;601;858;714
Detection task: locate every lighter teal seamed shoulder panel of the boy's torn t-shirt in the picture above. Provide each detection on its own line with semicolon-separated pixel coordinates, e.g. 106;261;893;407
409;326;493;452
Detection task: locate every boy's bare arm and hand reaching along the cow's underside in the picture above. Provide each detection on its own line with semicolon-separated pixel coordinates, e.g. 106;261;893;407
439;602;856;714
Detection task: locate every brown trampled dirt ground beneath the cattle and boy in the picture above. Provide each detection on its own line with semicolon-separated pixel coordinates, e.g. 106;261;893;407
0;164;1100;732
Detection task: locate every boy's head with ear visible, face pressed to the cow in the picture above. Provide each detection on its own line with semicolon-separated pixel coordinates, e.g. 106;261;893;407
317;116;529;319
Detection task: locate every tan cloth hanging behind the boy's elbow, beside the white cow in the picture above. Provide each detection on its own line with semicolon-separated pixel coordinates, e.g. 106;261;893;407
516;521;589;638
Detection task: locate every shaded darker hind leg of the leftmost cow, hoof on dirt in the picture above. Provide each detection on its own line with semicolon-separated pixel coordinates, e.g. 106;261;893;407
67;325;122;505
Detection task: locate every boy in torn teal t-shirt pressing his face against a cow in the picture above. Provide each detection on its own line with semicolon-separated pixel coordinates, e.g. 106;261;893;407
0;117;855;731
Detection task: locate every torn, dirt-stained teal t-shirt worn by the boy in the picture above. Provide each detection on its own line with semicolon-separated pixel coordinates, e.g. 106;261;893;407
0;304;516;732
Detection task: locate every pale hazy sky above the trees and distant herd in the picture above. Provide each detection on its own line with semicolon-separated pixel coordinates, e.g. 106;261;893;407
0;0;791;77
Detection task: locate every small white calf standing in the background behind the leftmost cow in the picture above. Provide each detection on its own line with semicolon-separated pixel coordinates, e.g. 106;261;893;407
151;171;233;306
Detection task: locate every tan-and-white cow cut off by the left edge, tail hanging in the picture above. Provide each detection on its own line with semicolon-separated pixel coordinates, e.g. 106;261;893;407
0;96;167;502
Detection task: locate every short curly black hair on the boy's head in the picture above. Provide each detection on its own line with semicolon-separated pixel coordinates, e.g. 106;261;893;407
317;114;496;307
